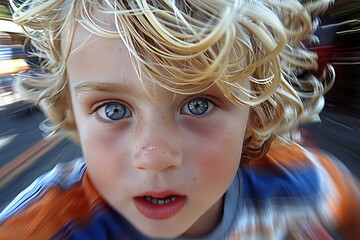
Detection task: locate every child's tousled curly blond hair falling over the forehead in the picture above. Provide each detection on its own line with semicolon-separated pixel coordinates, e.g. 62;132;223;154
10;0;334;159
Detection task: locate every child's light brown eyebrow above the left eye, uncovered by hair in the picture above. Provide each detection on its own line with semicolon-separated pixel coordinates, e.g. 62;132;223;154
74;82;129;95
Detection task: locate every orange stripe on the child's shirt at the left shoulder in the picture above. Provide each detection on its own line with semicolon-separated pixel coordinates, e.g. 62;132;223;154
0;171;105;240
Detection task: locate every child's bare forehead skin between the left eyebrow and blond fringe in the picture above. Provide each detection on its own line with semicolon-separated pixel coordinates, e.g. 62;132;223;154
67;25;181;100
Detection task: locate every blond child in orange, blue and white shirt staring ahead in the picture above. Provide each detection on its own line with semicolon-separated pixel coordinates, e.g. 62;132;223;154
0;0;360;239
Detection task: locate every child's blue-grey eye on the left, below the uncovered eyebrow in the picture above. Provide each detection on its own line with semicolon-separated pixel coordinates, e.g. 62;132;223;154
96;102;132;121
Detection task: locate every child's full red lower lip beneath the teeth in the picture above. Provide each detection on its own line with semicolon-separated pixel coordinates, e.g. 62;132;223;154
134;196;186;220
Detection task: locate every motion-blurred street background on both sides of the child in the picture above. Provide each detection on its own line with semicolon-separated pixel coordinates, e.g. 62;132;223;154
0;0;360;211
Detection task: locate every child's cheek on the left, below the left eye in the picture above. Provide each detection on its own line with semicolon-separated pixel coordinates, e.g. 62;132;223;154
79;124;132;203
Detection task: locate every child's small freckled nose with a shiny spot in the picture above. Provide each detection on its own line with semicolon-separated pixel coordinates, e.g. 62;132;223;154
134;115;182;172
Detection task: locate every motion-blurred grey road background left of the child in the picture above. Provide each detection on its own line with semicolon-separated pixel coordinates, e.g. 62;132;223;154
0;0;81;211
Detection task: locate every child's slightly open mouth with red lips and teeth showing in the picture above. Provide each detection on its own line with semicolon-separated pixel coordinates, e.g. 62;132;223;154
134;194;187;220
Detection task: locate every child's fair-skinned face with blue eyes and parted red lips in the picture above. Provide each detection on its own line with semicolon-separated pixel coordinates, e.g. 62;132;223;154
68;24;249;237
